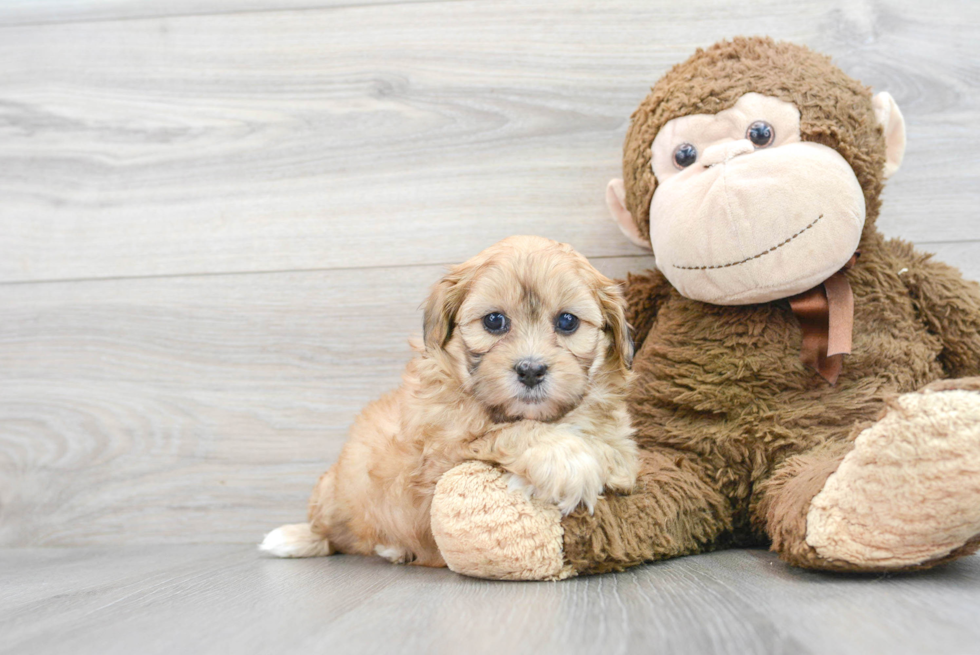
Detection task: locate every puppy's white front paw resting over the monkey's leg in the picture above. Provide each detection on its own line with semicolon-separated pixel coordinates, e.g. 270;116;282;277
508;442;605;514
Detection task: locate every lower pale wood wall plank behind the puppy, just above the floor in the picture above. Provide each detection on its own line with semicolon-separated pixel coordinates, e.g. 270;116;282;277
0;258;653;546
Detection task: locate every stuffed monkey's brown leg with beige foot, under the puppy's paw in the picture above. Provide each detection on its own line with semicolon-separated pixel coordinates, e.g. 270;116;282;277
432;449;731;580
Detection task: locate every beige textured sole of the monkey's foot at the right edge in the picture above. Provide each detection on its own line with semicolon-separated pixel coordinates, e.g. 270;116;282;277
806;378;980;570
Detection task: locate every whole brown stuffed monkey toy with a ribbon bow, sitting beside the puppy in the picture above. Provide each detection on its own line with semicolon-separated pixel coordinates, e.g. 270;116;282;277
432;38;980;579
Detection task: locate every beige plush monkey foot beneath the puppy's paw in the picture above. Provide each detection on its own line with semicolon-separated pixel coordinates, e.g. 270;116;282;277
432;462;574;580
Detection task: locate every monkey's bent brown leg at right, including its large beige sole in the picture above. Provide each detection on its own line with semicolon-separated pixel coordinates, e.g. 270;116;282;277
754;378;980;571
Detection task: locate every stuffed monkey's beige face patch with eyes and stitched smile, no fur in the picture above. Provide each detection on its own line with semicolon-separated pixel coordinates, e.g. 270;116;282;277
650;93;865;305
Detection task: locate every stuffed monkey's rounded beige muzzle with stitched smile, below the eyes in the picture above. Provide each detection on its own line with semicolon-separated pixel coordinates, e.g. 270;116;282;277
650;142;865;305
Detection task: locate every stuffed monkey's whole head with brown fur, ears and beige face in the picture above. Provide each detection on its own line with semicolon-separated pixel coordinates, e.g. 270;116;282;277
606;37;905;305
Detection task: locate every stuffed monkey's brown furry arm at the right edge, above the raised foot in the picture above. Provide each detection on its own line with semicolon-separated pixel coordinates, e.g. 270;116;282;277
902;246;980;378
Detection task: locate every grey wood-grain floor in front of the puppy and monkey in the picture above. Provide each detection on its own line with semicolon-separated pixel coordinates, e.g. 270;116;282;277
0;546;980;655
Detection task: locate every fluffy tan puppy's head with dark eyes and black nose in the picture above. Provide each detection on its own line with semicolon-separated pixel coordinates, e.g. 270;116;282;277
424;237;633;422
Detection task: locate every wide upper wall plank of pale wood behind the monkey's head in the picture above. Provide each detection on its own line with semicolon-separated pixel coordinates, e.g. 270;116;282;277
0;0;980;281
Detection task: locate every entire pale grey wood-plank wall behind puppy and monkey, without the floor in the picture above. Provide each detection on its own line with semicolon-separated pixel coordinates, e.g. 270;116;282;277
0;0;980;546
